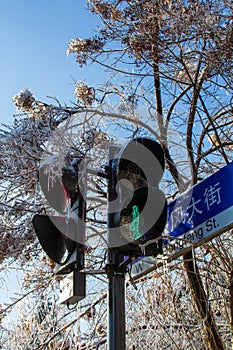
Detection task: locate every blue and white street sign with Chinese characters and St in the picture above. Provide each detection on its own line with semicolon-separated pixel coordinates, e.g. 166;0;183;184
131;162;233;278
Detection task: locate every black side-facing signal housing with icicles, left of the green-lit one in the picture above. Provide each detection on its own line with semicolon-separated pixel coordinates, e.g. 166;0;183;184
32;160;86;274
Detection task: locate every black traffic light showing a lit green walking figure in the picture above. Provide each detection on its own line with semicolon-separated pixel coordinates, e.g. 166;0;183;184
108;137;167;257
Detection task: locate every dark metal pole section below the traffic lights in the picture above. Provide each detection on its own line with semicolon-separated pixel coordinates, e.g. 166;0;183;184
107;248;125;350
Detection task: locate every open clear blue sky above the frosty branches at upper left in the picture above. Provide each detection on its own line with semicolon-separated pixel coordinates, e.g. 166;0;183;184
0;0;101;123
